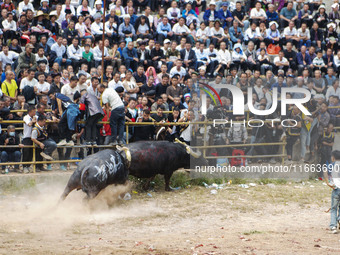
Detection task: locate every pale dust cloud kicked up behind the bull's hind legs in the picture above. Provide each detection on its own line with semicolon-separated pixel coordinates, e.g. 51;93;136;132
0;181;160;236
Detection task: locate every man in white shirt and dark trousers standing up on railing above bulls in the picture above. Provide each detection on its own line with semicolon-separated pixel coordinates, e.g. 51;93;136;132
98;85;125;144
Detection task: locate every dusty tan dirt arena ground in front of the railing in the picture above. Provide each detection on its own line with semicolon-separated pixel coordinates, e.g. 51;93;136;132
0;181;340;254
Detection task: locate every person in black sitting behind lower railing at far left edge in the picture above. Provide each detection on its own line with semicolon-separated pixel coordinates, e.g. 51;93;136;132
0;125;23;173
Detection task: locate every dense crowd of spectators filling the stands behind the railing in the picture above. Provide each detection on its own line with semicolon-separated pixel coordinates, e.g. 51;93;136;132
0;0;340;172
